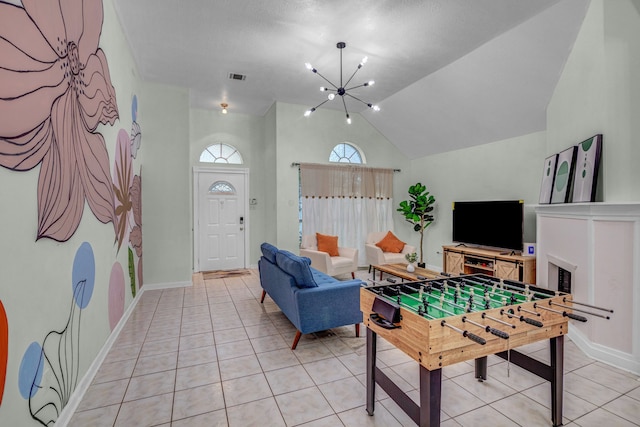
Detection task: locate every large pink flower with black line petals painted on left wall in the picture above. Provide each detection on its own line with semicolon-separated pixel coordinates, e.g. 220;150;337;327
0;0;118;241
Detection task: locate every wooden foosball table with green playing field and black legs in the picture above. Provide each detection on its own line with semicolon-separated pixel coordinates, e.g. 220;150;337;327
360;274;612;427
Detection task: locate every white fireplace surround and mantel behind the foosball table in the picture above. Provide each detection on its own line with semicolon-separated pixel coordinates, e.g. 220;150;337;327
535;203;640;374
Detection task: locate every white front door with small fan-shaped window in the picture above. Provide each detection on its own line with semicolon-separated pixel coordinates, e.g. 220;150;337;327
194;169;247;271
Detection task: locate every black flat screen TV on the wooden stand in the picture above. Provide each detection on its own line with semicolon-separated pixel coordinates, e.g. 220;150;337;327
453;200;524;251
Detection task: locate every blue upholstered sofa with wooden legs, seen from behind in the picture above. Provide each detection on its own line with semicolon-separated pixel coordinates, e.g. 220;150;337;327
258;243;363;350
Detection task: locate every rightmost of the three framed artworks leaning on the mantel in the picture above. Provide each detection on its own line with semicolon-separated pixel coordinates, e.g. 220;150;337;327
572;134;602;203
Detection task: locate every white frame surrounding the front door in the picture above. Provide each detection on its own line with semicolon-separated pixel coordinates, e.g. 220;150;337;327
193;166;251;272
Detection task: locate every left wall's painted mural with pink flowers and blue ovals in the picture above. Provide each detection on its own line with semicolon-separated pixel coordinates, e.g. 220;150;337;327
0;0;142;425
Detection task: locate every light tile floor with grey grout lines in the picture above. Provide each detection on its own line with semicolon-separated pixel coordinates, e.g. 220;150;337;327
69;271;640;427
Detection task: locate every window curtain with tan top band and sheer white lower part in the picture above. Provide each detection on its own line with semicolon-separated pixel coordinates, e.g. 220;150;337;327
300;163;393;265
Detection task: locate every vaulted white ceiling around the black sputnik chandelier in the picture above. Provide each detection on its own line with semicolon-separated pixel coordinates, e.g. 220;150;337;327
114;0;589;157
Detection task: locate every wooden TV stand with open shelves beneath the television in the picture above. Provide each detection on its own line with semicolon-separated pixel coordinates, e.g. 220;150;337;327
442;246;536;285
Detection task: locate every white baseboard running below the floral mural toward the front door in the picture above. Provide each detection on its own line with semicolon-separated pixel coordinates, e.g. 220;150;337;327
55;281;193;427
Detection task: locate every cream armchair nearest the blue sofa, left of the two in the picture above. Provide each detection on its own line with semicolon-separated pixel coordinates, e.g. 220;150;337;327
300;234;358;279
